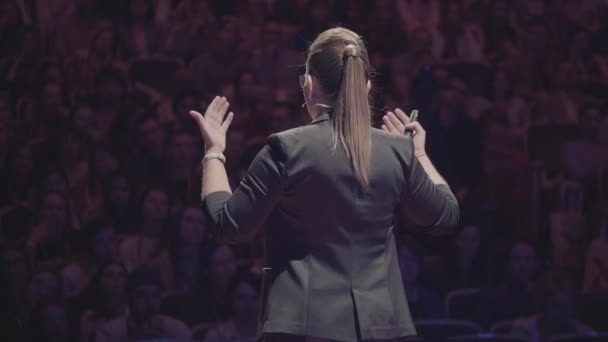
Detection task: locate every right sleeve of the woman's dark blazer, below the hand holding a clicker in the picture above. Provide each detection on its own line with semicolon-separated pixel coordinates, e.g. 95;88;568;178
399;140;460;235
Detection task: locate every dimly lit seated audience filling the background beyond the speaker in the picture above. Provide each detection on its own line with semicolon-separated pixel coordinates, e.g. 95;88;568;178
0;0;608;342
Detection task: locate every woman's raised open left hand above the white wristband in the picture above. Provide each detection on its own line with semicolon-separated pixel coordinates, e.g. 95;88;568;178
190;96;234;153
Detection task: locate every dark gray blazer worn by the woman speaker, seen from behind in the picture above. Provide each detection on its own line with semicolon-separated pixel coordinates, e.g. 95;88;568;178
203;114;459;341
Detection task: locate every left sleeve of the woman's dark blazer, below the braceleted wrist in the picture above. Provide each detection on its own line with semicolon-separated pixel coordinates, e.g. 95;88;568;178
202;135;286;242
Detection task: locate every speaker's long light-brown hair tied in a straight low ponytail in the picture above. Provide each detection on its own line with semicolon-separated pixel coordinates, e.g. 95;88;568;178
306;27;371;188
